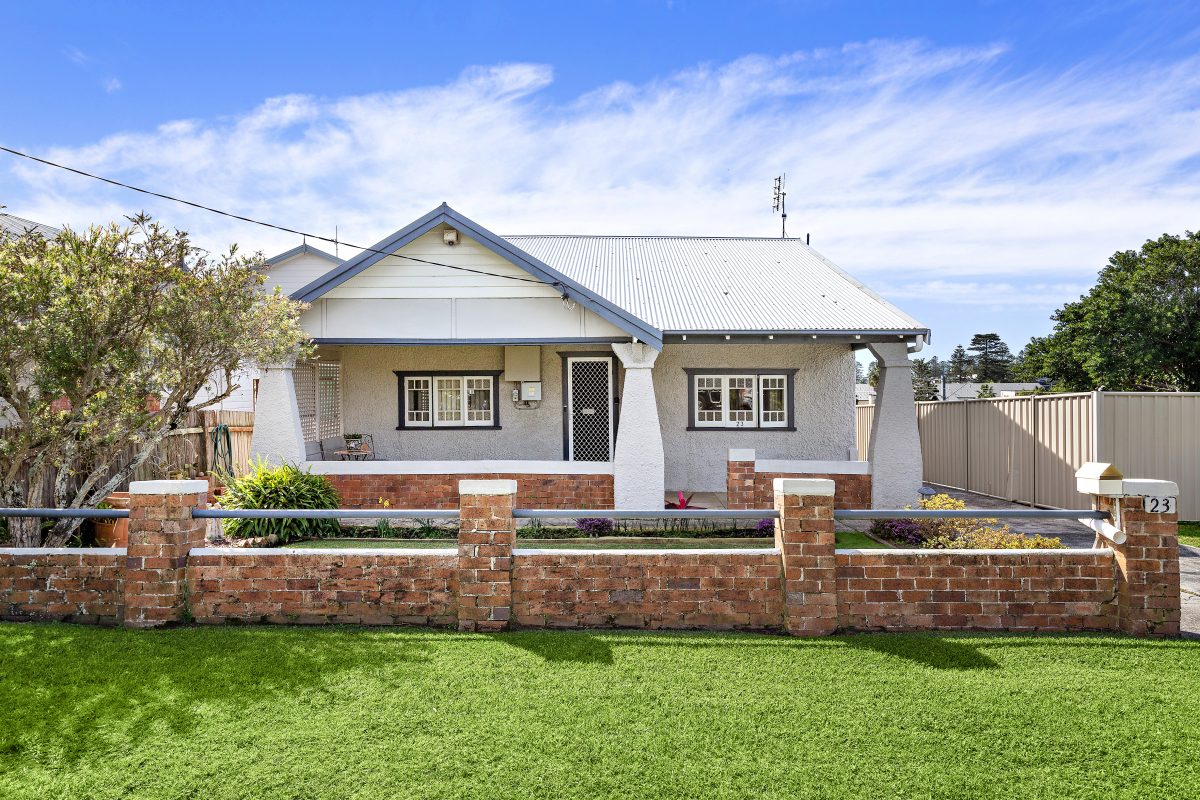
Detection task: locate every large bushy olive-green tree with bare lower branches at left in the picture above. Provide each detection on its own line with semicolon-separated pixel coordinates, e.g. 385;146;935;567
0;216;311;547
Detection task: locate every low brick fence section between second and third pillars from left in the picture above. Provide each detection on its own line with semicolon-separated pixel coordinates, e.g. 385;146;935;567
512;551;784;631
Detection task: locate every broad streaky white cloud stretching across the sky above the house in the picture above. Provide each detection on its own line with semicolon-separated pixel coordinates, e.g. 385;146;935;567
7;41;1200;306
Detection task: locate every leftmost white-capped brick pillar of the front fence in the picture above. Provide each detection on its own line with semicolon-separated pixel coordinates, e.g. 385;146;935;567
125;481;209;627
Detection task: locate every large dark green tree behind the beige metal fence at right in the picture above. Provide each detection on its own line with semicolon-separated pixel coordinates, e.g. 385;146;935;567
1019;231;1200;392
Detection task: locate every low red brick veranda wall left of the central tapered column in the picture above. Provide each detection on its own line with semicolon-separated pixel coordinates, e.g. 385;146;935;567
326;473;612;509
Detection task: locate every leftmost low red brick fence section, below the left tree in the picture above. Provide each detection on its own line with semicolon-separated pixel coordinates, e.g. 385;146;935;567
0;551;125;625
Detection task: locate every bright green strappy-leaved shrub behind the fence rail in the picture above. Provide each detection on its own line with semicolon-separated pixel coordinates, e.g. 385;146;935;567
221;461;342;543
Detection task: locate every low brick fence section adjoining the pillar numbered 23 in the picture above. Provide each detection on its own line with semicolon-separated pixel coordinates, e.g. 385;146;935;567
838;551;1117;631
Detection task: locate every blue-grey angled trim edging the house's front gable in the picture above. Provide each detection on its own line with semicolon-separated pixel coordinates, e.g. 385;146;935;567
292;203;662;350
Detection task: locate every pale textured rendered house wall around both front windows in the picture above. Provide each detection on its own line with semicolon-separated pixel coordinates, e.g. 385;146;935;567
322;344;854;492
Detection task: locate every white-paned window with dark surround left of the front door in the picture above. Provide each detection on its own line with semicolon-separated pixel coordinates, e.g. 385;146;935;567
396;372;499;429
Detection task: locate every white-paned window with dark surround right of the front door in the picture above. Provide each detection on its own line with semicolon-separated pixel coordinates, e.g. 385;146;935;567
688;371;794;428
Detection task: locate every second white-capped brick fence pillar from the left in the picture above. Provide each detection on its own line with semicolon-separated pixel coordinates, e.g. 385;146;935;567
458;481;517;632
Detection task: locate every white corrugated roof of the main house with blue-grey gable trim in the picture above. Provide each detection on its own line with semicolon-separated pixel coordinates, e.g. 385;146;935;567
292;203;929;347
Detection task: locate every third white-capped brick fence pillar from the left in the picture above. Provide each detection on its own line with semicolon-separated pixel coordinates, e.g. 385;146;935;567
775;477;838;636
